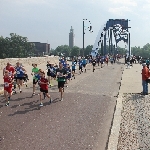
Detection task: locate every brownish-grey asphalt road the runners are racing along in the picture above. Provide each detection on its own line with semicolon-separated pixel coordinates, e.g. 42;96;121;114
0;61;123;150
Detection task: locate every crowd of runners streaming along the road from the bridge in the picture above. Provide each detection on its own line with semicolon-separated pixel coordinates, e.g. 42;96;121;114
3;57;112;106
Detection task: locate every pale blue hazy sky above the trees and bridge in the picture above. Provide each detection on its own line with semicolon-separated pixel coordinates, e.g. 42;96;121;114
0;0;150;49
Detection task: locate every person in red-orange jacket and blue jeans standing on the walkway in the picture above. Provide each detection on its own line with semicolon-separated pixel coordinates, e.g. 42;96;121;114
141;63;149;95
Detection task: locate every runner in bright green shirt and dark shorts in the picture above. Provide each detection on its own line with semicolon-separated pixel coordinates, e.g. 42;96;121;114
31;64;39;96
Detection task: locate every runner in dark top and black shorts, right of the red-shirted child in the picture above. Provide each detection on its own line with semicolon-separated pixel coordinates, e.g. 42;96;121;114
56;62;67;101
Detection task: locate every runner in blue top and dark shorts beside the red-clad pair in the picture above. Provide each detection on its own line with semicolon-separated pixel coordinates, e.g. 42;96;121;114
15;62;26;93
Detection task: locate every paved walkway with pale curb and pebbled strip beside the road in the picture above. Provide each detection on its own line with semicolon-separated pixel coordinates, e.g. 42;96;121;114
108;64;150;150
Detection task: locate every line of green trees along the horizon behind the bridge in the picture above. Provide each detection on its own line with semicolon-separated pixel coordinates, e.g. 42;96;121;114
0;33;150;59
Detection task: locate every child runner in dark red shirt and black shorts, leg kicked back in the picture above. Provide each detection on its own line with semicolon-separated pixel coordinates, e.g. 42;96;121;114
39;70;52;106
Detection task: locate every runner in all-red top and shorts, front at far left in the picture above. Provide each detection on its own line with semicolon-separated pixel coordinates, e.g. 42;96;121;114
3;70;12;106
